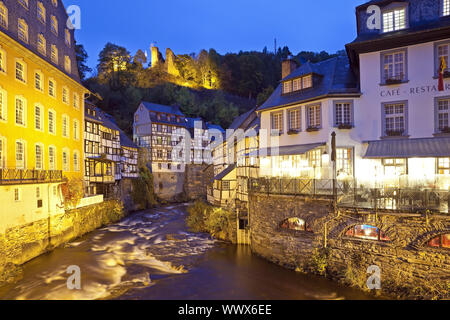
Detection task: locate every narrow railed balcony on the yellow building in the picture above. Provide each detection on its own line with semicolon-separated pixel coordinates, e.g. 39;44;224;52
0;169;63;185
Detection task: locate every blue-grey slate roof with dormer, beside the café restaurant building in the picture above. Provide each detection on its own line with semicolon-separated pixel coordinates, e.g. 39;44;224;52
257;55;360;111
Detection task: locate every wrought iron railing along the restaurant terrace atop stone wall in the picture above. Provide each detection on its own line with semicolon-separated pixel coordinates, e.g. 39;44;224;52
248;178;450;213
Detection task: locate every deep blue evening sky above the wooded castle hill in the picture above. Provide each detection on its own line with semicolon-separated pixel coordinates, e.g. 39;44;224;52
63;0;365;75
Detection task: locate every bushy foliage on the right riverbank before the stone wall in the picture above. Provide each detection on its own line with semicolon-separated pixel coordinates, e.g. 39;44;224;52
186;200;236;240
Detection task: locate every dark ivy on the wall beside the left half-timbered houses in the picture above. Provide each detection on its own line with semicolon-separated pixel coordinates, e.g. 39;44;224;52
131;167;158;209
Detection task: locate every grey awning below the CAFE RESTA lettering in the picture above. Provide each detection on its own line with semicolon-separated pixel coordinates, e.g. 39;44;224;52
364;137;450;159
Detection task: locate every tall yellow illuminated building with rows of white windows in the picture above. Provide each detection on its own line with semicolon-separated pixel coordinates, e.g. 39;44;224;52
0;0;87;228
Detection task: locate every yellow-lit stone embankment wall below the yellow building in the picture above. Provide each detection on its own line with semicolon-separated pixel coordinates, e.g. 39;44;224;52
0;200;125;282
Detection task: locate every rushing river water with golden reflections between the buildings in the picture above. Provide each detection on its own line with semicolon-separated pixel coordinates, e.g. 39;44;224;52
0;204;370;300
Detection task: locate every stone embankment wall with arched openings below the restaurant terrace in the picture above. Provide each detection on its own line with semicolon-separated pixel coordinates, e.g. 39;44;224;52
249;194;450;299
